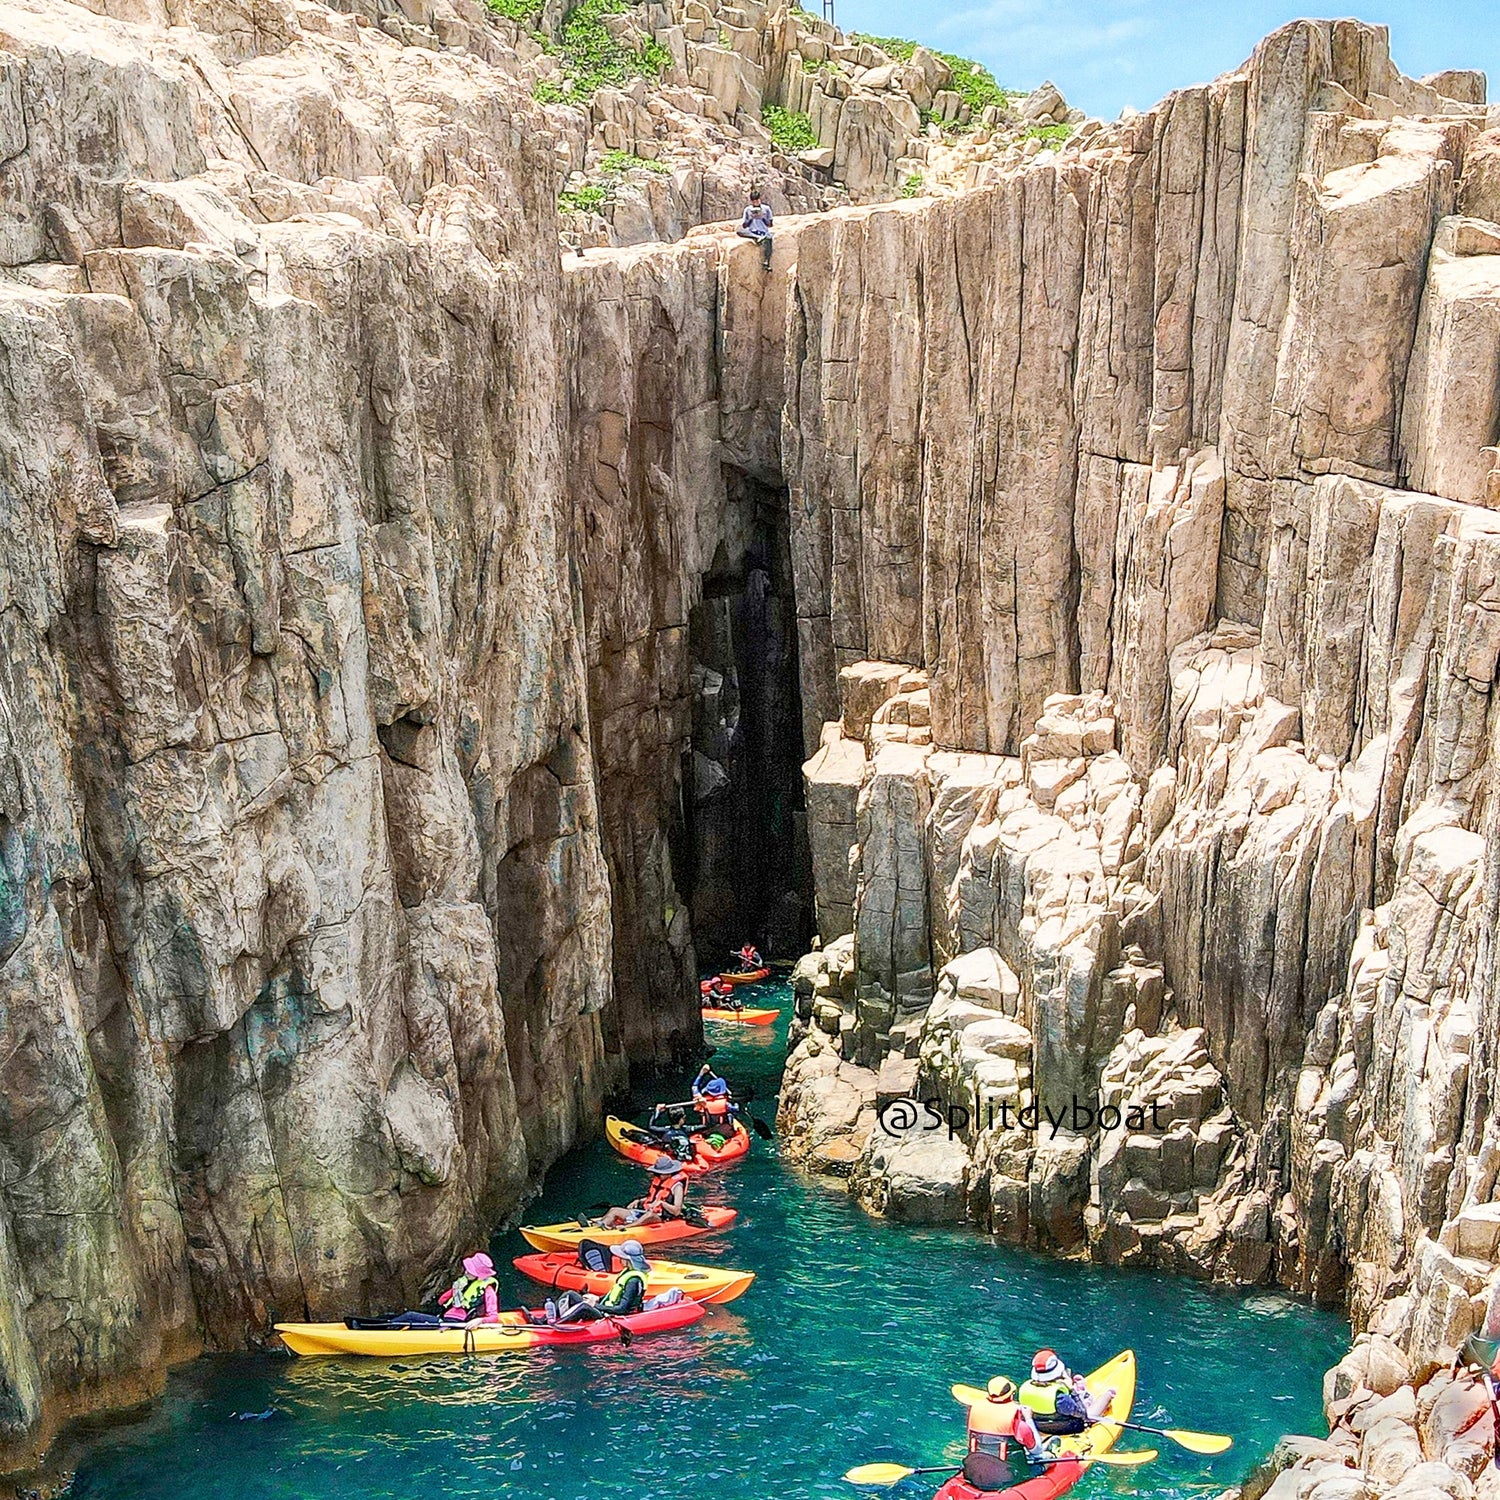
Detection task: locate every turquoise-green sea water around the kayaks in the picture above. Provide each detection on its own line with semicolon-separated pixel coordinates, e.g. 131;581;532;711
72;984;1349;1500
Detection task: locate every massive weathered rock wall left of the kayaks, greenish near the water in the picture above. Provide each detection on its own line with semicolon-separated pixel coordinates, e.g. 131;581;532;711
0;6;627;1460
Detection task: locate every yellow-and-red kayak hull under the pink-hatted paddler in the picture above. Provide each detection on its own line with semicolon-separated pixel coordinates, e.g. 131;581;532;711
276;1299;705;1359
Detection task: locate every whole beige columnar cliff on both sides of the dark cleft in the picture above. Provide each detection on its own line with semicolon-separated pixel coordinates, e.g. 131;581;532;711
0;0;1500;1482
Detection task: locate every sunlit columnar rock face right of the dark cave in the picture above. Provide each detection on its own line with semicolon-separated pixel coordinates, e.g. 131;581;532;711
750;23;1500;1488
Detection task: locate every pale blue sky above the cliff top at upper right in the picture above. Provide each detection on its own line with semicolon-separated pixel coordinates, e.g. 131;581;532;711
834;0;1500;119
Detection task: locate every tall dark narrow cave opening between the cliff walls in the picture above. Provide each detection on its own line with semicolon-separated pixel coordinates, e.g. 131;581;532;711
674;470;813;969
